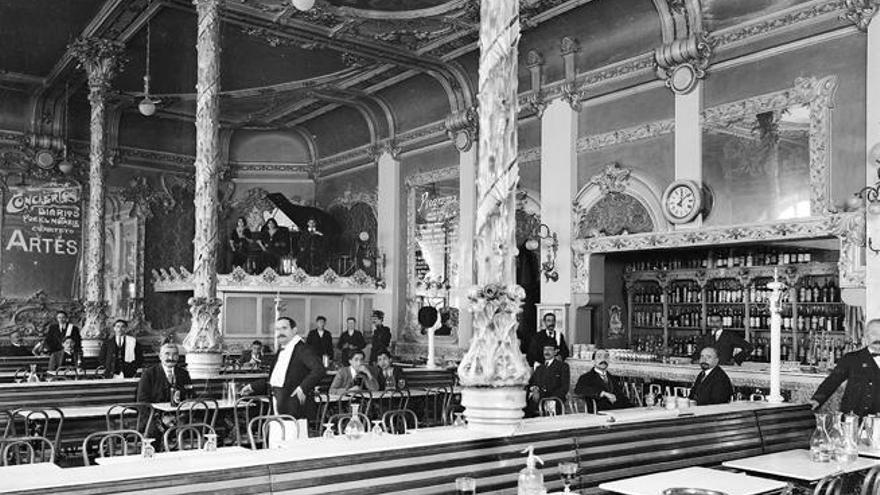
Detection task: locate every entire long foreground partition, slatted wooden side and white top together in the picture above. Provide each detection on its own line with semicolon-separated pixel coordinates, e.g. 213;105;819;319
0;402;814;495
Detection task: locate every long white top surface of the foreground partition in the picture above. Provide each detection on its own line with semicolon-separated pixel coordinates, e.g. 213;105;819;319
0;402;791;493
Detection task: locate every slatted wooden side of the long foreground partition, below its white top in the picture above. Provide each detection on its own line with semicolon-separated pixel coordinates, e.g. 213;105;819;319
0;405;812;495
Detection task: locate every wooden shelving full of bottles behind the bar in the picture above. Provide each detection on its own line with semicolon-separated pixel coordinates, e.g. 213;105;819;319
624;244;851;362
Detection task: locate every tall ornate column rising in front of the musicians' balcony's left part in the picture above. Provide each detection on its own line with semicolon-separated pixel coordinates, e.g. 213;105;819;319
183;0;223;378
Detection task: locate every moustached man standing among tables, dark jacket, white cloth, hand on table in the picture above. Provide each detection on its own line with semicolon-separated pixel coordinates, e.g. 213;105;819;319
241;316;327;419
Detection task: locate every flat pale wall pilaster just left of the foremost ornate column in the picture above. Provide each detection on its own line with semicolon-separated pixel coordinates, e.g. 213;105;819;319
444;108;477;348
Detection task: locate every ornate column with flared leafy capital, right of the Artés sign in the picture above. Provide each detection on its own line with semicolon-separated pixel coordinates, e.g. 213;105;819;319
70;38;124;357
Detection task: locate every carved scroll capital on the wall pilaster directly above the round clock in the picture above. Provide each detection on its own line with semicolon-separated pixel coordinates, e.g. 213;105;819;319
654;33;712;95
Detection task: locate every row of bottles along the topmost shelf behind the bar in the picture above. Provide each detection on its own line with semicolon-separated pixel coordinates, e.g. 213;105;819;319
624;249;814;272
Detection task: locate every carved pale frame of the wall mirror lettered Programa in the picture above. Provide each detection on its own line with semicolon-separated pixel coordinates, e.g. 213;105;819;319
404;166;460;344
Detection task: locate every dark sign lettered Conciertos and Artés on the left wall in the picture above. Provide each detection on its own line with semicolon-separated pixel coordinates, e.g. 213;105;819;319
0;183;82;299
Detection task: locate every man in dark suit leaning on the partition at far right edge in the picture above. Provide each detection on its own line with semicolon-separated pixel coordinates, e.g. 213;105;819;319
810;318;880;417
